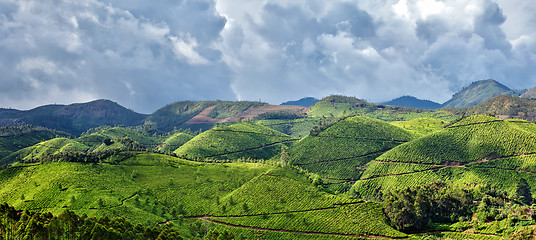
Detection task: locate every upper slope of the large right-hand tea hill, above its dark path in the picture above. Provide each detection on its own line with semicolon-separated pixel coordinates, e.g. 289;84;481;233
378;116;536;164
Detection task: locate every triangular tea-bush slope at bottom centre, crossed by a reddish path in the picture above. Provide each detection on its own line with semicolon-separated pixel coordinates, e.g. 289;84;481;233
209;168;407;238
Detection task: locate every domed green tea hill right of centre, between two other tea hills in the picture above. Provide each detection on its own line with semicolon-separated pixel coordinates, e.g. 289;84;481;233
288;116;412;191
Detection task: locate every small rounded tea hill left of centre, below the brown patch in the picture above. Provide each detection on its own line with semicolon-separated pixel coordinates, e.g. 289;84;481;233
175;122;296;159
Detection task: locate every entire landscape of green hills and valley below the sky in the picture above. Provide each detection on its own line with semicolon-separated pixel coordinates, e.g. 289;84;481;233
0;81;536;239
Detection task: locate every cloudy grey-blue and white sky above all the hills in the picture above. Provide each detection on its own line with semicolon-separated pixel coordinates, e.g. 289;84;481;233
0;0;536;113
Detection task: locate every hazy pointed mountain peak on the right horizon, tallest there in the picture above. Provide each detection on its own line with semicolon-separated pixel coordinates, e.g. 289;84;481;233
442;79;519;107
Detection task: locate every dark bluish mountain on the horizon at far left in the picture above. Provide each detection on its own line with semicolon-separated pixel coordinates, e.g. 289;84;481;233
0;100;146;135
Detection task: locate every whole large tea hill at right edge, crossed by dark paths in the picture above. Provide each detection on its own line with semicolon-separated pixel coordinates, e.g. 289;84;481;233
352;115;536;197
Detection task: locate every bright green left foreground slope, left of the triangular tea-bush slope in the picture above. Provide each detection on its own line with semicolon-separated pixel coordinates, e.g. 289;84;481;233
0;154;273;224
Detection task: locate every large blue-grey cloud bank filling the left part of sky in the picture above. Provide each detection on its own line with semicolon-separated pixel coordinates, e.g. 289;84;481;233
0;0;235;112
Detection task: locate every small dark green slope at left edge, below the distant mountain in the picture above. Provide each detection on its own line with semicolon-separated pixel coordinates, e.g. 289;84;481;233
0;125;68;160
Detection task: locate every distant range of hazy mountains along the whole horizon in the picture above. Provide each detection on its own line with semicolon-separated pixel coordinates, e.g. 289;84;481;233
0;79;536;136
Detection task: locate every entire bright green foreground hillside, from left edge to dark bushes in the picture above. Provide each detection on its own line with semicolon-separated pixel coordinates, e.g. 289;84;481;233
0;153;407;239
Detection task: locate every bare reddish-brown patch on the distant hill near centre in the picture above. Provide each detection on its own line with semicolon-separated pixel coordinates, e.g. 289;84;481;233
186;105;309;125
